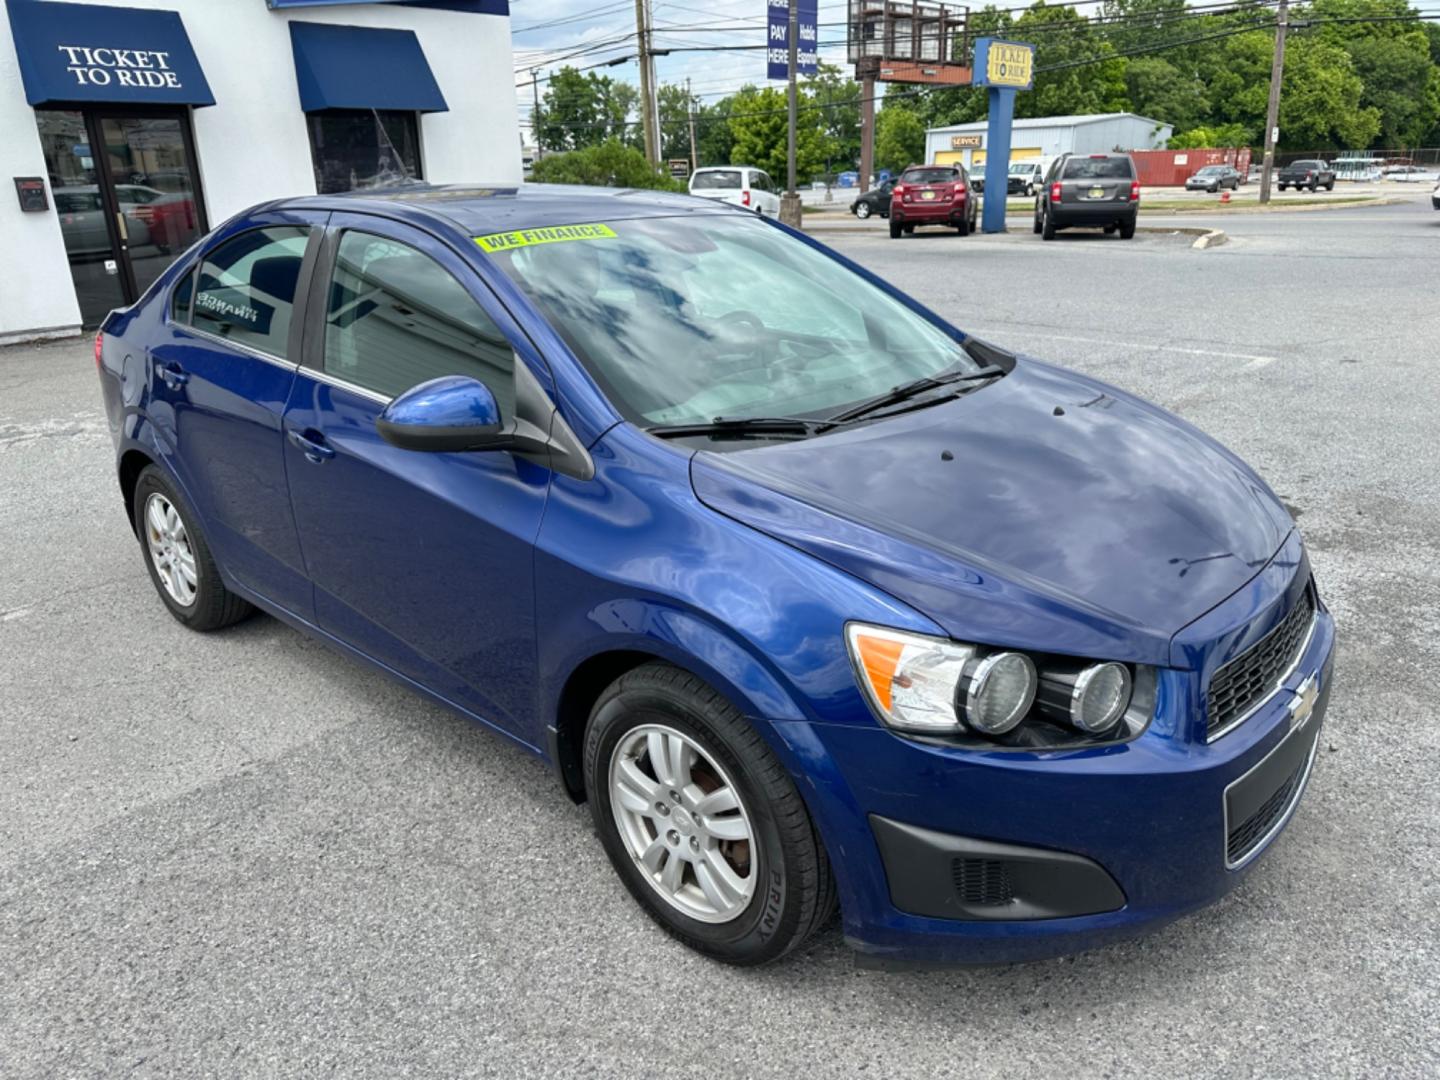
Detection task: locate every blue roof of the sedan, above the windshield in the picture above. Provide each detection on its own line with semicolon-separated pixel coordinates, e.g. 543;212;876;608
256;182;747;236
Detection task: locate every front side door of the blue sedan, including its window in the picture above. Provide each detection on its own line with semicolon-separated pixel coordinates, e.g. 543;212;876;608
284;215;552;742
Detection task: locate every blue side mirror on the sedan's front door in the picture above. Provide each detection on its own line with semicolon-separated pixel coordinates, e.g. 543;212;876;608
374;374;510;454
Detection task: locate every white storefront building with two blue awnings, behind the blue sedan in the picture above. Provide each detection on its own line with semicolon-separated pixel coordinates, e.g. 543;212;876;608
0;0;521;344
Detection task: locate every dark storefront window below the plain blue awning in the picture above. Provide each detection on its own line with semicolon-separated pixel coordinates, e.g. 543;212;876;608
310;109;422;194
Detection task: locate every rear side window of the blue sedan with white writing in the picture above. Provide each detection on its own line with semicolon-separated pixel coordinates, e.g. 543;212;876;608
190;226;310;357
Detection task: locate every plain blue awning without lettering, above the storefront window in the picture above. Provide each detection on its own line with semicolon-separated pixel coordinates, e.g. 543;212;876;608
289;23;449;112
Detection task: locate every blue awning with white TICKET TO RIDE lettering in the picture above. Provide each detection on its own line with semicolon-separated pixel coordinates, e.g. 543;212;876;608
6;0;215;105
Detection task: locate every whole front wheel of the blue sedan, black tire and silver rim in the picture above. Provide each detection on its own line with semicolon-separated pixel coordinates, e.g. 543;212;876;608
585;664;835;966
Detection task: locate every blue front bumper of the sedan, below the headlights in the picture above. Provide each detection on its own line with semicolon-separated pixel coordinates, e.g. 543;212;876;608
792;609;1335;966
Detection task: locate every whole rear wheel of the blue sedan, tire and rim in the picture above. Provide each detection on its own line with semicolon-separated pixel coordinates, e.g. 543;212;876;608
134;465;255;631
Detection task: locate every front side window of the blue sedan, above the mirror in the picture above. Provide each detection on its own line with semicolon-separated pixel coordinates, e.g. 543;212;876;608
325;232;516;419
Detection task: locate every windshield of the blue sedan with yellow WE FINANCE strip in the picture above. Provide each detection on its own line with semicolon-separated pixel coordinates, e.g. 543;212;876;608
480;215;979;426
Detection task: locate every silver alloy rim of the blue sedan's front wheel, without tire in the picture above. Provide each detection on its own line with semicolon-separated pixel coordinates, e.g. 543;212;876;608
609;724;757;923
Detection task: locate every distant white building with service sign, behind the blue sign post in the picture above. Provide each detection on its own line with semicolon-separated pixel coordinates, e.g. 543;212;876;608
924;112;1175;171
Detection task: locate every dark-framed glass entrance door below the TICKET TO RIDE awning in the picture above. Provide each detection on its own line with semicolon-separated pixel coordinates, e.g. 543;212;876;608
35;109;206;325
